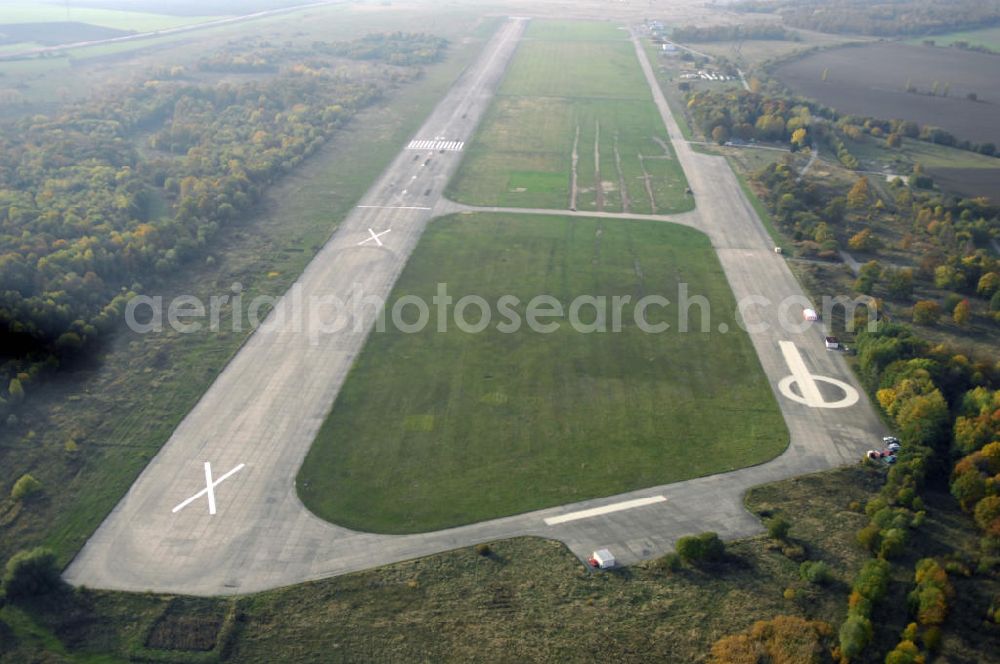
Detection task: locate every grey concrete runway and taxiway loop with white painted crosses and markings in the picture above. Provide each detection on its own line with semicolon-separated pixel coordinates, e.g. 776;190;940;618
64;20;883;595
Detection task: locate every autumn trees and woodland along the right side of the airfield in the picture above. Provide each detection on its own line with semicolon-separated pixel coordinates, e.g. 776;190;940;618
689;84;1000;664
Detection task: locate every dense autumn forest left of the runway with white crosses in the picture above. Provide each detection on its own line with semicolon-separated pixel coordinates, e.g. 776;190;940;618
0;33;444;416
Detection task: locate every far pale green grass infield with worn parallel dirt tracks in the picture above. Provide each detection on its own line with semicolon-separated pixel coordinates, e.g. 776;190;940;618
449;20;694;213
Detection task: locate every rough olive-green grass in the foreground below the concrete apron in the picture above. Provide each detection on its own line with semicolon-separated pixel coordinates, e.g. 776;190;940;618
11;467;997;663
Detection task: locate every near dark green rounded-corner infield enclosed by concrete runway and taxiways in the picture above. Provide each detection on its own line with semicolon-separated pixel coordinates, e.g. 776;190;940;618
298;214;788;532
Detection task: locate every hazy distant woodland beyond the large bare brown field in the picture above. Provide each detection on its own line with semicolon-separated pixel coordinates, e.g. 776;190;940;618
733;0;1000;37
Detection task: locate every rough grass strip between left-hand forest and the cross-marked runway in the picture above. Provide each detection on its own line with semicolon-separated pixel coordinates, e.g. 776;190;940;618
0;24;495;563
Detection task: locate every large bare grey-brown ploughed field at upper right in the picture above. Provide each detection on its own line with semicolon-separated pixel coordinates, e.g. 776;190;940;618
774;43;1000;144
